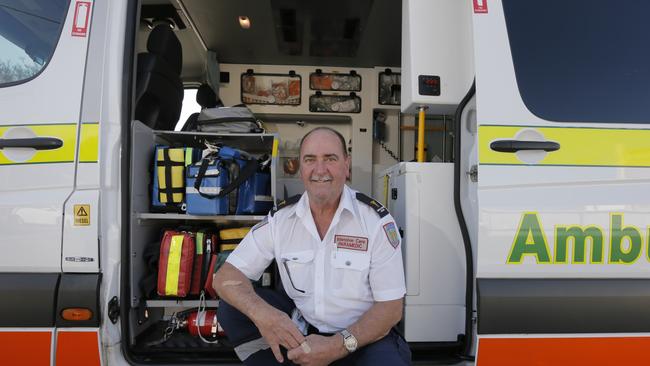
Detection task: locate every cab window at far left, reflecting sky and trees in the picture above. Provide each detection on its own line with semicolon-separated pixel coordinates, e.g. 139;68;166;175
0;0;69;85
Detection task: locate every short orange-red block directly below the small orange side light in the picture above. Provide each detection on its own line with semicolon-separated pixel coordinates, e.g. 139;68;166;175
55;330;101;366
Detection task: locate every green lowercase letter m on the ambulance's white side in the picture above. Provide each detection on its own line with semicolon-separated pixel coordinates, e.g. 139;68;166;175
555;226;603;263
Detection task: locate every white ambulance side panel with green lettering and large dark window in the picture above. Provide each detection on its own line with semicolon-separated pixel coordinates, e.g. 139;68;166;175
473;0;650;366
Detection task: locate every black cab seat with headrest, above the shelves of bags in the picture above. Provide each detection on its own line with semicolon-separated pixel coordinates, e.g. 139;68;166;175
135;25;183;130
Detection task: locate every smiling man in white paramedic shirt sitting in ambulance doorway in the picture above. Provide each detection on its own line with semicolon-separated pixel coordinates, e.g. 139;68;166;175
214;128;411;365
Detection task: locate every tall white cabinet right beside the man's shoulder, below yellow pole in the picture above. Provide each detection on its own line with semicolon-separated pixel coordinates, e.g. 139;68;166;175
381;163;465;343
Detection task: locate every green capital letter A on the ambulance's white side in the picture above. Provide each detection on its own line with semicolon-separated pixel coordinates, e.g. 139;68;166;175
507;212;550;264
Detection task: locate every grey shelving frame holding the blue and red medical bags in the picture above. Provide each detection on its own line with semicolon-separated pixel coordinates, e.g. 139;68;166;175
128;121;279;342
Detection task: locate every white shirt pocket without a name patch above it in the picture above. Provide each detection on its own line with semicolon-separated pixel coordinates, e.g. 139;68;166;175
280;250;314;297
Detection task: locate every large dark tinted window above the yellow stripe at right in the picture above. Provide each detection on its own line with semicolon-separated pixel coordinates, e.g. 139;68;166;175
503;0;650;123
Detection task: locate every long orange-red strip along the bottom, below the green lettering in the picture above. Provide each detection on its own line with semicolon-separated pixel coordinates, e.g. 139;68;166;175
477;337;650;366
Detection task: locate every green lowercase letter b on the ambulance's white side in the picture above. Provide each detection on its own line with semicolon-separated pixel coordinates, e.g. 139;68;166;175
609;214;643;264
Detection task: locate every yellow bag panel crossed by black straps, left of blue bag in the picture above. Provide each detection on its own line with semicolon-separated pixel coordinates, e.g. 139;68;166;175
156;148;185;203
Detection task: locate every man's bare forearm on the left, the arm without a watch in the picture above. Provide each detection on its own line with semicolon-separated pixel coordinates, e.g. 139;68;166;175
214;262;271;322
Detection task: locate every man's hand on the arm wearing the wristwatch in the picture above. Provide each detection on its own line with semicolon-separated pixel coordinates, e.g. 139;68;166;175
287;334;347;366
